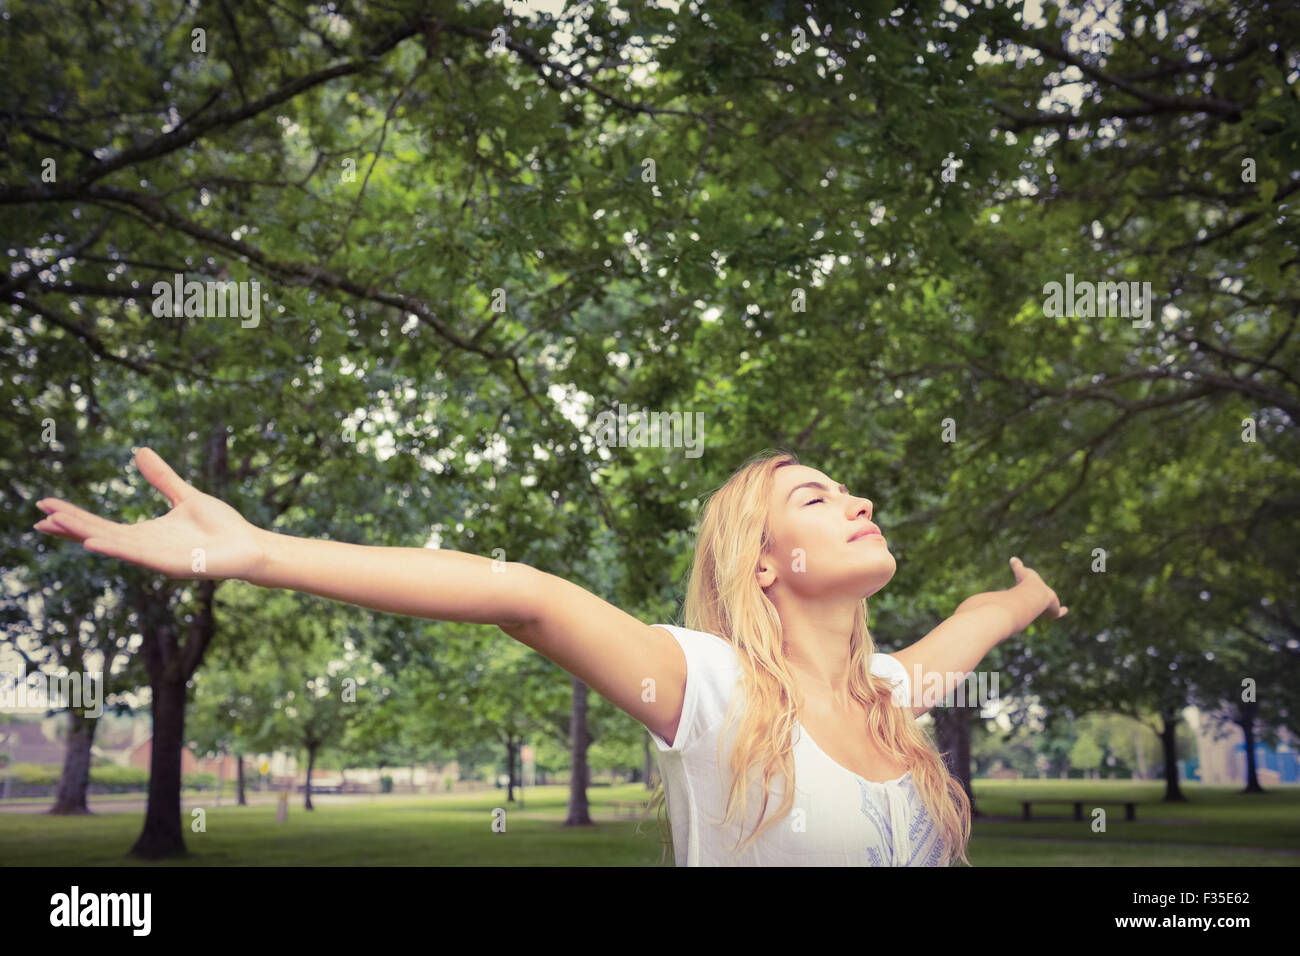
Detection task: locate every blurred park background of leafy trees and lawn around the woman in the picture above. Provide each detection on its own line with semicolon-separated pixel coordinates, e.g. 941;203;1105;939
0;0;1300;866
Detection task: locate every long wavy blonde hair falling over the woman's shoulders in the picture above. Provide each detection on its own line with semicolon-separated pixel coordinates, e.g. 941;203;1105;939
650;451;971;865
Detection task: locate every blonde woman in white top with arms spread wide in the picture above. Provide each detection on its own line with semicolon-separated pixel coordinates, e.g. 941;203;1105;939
35;449;1067;866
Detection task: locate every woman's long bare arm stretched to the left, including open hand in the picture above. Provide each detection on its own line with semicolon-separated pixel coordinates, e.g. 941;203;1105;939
35;449;686;741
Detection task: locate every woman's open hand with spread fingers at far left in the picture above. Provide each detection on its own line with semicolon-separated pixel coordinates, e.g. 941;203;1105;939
34;447;265;580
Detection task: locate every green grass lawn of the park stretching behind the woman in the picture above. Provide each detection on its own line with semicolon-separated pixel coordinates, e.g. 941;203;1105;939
0;780;1300;866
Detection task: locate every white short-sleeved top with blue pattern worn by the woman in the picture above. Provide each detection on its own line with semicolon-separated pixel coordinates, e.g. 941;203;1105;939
647;624;946;866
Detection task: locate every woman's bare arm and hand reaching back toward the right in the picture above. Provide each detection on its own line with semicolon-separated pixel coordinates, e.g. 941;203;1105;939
893;558;1070;717
